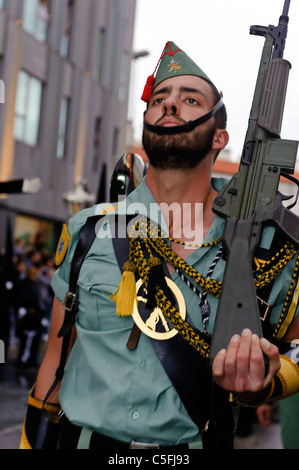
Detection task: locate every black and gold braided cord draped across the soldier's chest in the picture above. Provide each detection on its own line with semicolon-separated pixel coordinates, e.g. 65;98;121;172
128;220;299;357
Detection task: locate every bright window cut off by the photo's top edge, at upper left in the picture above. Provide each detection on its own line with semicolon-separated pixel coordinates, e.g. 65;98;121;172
23;0;50;42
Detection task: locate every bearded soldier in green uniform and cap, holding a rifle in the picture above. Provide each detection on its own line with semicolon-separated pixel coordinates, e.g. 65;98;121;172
22;42;299;452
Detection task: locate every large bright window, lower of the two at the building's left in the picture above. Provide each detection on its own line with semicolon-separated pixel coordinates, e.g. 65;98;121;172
14;70;42;146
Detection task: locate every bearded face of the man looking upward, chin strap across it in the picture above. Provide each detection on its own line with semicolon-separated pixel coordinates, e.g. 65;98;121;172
142;75;215;169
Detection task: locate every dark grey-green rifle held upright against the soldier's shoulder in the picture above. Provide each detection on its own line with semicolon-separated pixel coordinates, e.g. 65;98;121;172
210;0;299;362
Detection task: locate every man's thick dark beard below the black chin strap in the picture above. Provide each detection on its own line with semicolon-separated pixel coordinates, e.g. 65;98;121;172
142;125;216;170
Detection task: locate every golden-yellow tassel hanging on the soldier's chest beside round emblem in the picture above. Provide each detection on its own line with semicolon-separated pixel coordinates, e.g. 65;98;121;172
111;261;137;317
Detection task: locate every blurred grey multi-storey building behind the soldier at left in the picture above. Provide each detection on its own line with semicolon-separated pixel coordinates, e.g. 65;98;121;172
0;0;136;253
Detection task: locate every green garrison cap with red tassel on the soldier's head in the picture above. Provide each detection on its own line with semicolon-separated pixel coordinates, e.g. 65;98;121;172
141;41;212;102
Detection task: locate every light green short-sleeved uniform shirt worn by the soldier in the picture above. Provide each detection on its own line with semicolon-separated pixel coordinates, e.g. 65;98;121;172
52;179;294;445
